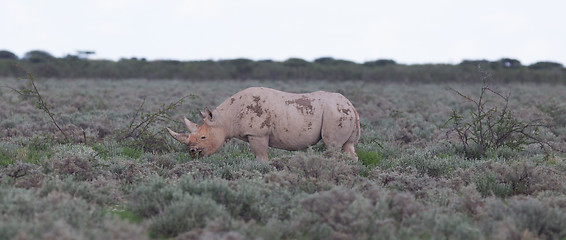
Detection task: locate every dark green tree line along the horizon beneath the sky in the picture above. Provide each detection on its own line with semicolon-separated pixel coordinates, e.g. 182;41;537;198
0;50;566;83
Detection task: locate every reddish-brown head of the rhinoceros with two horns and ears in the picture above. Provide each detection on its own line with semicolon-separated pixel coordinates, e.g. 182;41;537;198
167;109;226;158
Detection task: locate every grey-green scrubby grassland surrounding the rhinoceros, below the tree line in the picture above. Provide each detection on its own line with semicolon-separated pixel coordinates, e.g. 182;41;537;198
0;78;566;239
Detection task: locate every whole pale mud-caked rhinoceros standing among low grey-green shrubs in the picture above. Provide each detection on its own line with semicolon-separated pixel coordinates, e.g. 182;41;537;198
167;87;360;162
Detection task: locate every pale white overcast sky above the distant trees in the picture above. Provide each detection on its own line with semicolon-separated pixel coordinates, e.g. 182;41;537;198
0;0;566;65
